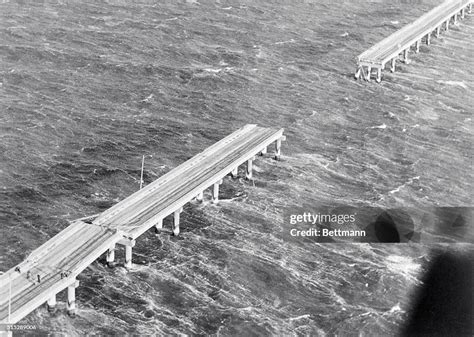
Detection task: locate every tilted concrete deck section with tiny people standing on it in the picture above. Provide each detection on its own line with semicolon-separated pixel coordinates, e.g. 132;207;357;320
0;221;122;323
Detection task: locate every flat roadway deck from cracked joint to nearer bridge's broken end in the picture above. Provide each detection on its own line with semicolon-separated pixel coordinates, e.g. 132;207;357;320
93;125;283;239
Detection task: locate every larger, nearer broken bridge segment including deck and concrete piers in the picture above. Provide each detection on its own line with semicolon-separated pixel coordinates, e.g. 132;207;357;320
0;124;285;334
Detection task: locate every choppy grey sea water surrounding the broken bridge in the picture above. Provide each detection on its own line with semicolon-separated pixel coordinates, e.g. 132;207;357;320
0;0;474;336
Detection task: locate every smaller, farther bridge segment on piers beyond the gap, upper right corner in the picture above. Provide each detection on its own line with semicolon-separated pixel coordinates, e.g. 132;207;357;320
355;0;473;82
